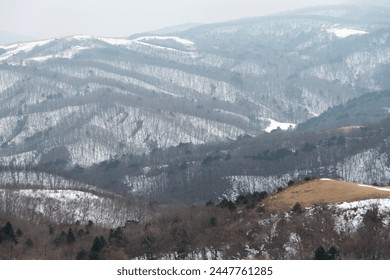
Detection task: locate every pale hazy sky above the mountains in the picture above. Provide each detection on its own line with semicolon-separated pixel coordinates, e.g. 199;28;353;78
0;0;356;38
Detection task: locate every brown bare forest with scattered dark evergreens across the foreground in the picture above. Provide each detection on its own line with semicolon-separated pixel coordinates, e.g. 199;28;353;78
0;180;390;260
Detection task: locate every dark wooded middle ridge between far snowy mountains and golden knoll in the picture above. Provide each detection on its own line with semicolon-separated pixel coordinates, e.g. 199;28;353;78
41;116;390;204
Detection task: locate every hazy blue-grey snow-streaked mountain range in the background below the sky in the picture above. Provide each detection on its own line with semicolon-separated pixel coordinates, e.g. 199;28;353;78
0;6;390;171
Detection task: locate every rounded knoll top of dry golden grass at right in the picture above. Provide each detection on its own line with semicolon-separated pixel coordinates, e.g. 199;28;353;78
265;180;390;211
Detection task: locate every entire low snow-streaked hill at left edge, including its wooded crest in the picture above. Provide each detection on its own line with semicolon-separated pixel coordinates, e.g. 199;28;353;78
0;171;150;227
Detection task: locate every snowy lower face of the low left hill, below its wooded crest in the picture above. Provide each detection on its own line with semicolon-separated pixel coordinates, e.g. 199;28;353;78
0;188;149;228
